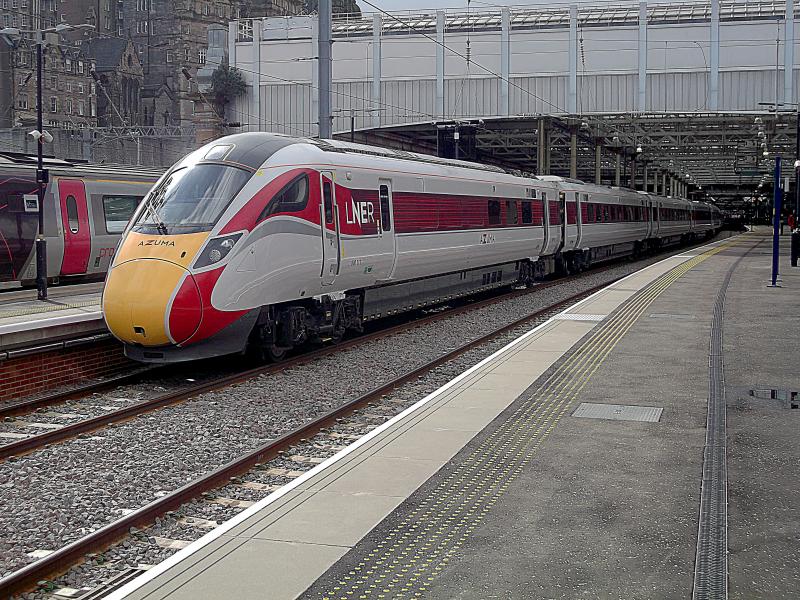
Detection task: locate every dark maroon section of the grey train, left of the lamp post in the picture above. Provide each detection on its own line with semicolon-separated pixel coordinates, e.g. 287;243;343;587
0;177;39;281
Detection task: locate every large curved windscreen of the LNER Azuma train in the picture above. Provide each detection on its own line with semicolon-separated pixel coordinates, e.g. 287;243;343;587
133;164;252;235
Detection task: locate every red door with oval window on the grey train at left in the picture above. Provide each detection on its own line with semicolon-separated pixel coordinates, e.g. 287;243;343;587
58;179;92;275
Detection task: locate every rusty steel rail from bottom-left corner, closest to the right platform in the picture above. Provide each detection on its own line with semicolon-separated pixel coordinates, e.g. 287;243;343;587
0;277;621;598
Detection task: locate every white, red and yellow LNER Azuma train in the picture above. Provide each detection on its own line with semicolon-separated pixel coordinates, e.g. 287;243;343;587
103;133;721;362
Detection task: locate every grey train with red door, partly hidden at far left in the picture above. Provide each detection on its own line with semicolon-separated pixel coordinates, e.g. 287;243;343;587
0;152;164;284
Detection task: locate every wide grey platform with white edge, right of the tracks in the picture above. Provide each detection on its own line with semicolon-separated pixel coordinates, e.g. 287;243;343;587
109;231;800;600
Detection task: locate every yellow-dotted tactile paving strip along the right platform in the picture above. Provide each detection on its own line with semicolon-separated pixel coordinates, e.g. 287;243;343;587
320;239;747;600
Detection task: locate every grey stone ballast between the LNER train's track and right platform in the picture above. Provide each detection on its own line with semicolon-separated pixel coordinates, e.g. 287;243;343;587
0;236;736;597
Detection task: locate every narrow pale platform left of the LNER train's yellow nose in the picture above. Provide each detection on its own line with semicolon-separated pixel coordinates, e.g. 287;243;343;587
0;283;107;358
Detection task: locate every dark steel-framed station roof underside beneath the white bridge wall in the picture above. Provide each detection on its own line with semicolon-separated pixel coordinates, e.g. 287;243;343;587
346;111;797;210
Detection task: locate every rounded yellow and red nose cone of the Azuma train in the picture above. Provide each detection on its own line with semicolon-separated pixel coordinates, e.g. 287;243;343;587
103;258;202;346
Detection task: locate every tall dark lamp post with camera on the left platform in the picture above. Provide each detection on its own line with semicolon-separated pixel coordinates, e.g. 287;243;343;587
0;23;94;300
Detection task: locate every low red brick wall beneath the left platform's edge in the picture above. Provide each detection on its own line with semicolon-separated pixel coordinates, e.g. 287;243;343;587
0;340;135;401
